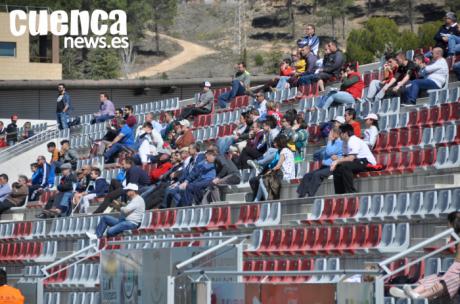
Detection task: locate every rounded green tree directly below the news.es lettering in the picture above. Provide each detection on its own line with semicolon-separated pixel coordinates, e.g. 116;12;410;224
86;49;120;80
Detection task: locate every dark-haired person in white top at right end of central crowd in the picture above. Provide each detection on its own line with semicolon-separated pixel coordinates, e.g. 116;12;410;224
249;134;295;202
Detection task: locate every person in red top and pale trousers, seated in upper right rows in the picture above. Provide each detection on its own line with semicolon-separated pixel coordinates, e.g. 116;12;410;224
366;56;399;101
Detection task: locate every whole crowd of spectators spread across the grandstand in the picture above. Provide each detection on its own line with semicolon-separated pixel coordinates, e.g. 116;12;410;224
0;13;460;237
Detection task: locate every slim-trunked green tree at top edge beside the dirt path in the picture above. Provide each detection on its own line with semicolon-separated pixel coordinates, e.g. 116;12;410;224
150;0;177;54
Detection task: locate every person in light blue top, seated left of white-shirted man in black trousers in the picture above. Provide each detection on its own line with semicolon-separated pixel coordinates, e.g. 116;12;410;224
297;127;343;198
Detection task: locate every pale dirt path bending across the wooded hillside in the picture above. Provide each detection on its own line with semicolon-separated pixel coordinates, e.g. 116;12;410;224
128;31;216;79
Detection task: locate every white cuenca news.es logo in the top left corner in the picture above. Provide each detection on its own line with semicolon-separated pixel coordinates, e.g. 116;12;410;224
10;9;129;49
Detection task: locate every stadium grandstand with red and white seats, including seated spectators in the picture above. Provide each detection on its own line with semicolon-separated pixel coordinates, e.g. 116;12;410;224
0;8;460;304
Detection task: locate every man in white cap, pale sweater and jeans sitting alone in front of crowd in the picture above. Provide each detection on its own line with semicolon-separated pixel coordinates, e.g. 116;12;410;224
92;183;145;239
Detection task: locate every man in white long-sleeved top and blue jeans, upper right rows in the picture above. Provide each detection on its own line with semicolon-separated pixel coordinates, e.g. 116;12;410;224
404;48;449;104
